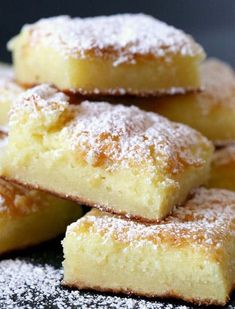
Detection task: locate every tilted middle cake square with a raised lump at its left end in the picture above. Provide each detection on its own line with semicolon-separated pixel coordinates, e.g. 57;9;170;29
0;85;213;221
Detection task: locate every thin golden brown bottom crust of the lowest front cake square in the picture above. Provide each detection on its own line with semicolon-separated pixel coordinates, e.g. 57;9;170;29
62;281;232;306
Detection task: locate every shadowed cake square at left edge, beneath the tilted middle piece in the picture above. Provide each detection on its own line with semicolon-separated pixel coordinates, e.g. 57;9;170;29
0;131;82;255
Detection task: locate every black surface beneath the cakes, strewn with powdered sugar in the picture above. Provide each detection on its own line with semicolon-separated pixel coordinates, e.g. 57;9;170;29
0;239;235;309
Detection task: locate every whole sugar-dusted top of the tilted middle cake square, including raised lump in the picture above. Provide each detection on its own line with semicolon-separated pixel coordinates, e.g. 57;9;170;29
10;85;212;174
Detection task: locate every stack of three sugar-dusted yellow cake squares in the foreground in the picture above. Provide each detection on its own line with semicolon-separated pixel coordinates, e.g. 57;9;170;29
0;14;235;305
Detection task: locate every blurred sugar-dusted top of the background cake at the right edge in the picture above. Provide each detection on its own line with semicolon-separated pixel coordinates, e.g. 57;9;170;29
200;59;235;113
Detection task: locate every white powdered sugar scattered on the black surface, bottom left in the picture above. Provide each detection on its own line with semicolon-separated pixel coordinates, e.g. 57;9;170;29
0;259;191;309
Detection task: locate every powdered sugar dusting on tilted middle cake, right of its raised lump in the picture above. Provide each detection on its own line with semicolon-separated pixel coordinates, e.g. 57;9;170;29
62;101;209;173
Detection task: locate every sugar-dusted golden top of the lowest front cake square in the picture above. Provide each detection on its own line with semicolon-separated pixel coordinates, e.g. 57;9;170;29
67;188;235;250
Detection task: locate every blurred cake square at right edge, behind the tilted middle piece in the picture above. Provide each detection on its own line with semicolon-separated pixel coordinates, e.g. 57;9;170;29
130;59;235;145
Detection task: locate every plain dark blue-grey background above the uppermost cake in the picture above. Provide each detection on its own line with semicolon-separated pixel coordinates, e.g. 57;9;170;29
0;0;235;66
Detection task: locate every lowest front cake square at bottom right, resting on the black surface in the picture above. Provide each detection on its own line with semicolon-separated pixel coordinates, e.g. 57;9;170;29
63;188;235;305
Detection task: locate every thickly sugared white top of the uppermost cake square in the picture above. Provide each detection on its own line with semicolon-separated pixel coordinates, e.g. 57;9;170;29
14;14;203;65
